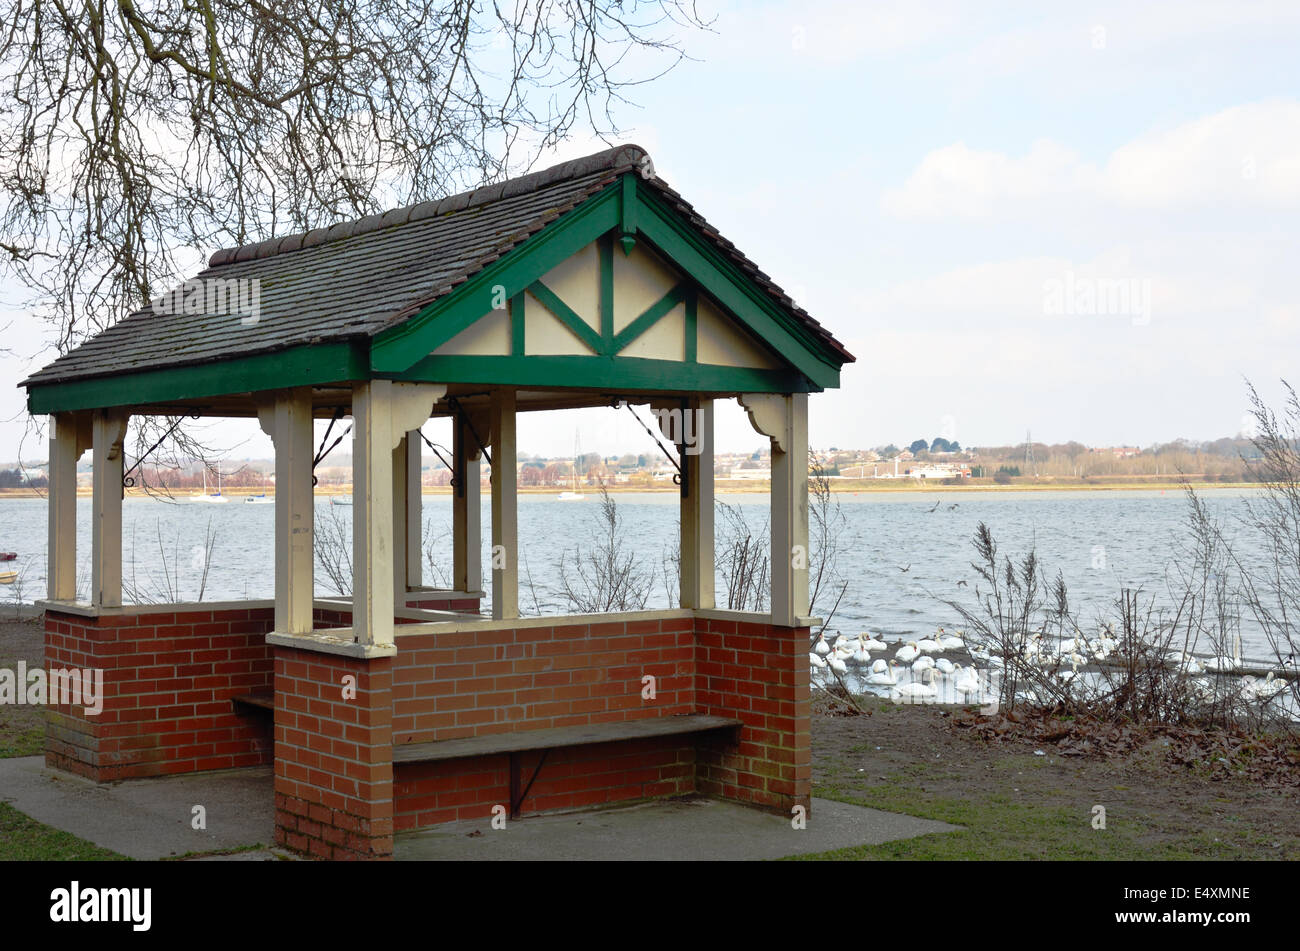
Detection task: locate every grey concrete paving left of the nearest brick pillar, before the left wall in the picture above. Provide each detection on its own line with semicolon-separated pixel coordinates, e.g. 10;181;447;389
0;756;277;860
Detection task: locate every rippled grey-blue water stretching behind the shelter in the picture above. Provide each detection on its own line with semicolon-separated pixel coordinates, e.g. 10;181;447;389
0;488;1268;656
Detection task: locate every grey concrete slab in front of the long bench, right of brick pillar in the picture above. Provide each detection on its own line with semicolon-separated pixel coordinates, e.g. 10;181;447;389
393;798;958;861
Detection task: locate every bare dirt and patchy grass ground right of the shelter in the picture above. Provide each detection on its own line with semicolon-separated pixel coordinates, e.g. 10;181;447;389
813;700;1300;859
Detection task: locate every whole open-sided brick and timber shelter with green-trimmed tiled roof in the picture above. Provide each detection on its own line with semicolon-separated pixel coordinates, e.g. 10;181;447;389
23;146;853;857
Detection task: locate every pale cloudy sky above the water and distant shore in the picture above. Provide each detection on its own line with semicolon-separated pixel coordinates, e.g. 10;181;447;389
0;0;1300;460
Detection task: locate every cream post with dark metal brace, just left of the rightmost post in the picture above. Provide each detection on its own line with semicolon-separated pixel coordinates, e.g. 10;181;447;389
681;399;714;609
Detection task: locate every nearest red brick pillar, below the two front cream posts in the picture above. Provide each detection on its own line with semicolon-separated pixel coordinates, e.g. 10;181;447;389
276;646;393;859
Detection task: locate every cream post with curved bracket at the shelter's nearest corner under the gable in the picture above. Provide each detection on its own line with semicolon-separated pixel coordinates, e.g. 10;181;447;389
352;379;447;646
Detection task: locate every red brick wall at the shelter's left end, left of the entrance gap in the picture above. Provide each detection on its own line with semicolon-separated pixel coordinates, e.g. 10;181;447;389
46;608;273;782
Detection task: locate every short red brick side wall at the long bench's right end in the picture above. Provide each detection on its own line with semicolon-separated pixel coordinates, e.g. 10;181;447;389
696;617;813;813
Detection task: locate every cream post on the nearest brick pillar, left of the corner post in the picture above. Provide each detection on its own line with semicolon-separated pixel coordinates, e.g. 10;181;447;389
257;386;316;634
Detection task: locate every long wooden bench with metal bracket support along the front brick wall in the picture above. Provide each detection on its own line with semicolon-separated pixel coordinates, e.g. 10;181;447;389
393;713;741;818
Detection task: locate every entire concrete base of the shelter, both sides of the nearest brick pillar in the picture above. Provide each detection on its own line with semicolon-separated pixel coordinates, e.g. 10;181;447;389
0;756;957;861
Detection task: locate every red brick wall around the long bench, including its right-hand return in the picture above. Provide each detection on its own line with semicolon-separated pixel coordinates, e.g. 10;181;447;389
382;617;811;830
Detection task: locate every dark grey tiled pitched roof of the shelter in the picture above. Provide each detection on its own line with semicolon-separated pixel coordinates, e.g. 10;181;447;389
25;146;853;385
